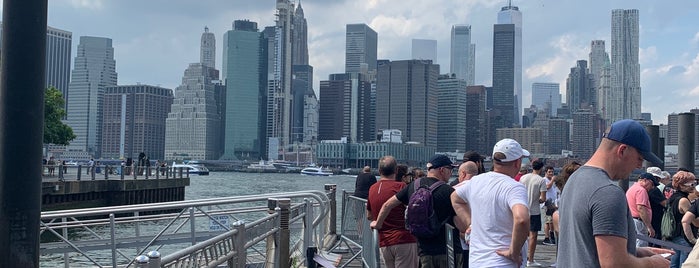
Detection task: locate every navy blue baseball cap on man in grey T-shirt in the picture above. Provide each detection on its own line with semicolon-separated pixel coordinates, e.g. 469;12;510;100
604;119;663;164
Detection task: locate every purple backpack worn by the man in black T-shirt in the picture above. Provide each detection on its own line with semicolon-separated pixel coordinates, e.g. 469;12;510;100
405;178;445;238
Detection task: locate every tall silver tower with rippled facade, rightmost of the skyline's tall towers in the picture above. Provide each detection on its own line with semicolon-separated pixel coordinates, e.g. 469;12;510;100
608;9;641;120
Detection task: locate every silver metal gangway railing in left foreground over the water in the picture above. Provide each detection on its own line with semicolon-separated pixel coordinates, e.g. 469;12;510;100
40;188;335;267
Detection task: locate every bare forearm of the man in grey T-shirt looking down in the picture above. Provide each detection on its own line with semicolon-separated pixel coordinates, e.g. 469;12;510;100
595;235;670;268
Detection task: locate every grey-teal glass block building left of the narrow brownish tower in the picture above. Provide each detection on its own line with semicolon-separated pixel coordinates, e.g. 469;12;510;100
437;74;464;152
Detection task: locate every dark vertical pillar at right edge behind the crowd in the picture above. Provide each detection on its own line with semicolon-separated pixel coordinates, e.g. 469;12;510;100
677;113;696;173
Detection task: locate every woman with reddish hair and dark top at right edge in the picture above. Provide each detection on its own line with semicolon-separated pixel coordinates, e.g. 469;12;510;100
667;171;696;268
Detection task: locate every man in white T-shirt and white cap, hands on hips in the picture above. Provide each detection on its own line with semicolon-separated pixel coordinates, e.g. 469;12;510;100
451;139;529;267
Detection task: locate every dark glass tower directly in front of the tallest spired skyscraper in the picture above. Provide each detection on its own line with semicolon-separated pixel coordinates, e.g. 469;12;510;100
491;24;519;127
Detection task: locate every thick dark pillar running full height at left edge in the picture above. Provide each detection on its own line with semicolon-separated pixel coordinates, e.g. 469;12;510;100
0;0;48;267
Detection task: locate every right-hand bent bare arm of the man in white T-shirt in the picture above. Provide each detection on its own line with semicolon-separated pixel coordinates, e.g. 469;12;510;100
495;204;529;263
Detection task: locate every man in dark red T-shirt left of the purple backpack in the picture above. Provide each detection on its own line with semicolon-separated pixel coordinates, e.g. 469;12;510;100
366;156;418;268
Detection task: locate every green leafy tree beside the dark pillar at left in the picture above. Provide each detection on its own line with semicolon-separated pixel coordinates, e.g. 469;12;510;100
44;87;75;145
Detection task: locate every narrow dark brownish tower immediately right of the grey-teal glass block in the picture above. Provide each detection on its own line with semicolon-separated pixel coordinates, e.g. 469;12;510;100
463;86;492;154
